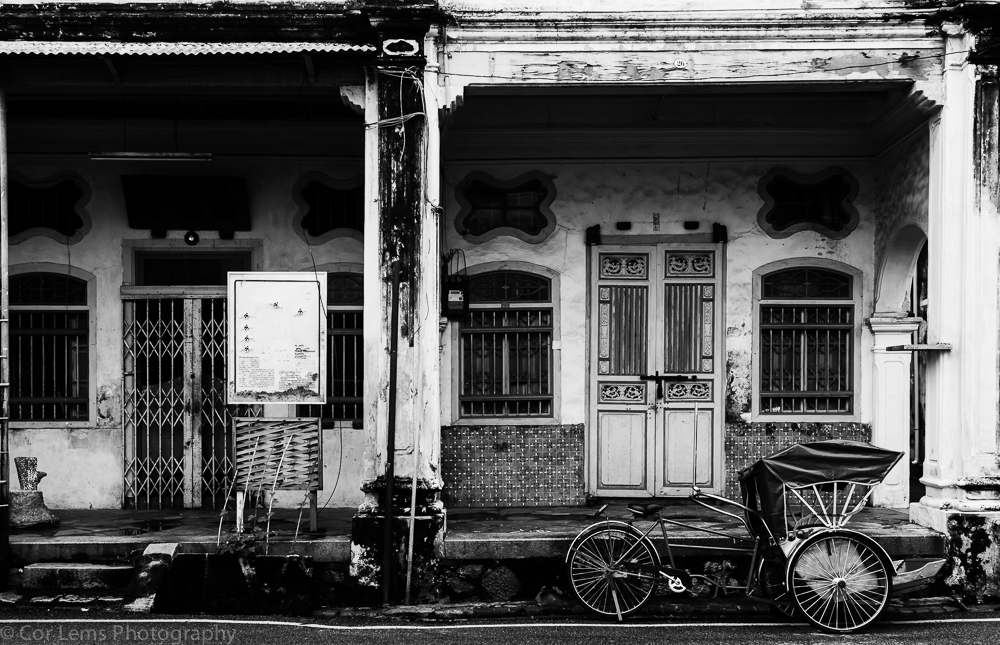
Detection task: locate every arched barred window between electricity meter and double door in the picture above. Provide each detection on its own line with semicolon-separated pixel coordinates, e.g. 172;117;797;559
458;271;553;417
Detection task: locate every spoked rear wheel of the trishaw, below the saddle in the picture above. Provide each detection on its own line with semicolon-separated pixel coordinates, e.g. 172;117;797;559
566;522;660;620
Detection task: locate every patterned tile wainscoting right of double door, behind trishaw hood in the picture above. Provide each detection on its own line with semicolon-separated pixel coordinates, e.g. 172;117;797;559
725;423;872;500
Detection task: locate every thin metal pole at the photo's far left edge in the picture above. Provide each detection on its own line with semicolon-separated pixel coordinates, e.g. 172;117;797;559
0;69;10;588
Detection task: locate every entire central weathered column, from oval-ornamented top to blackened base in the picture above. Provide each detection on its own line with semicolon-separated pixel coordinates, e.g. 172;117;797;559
351;25;444;602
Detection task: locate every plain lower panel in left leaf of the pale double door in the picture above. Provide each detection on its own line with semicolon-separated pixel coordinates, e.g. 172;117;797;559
597;412;646;489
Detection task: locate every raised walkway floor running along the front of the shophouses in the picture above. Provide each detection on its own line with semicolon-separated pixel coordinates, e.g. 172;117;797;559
10;503;946;564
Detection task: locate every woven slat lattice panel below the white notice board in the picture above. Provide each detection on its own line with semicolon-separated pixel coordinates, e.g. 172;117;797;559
233;417;323;490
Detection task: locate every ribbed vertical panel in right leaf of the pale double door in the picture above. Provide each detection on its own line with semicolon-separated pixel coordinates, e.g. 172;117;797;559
663;284;704;373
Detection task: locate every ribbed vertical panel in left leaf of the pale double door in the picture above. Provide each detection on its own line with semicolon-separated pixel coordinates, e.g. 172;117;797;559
608;286;649;376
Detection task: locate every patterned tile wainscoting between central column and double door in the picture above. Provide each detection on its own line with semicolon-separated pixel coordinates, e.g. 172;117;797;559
441;424;586;507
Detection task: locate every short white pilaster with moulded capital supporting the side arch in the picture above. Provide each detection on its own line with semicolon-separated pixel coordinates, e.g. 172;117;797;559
868;316;920;508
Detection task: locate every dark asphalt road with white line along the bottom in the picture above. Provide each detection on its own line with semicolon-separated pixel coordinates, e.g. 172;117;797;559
0;611;1000;645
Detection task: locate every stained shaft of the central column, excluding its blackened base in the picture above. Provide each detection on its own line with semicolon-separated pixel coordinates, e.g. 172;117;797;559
362;55;441;508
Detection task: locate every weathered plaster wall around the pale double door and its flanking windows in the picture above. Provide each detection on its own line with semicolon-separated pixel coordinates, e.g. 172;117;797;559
442;162;878;424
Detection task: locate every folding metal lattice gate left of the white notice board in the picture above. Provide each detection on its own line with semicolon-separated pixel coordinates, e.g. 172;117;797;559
123;294;252;509
